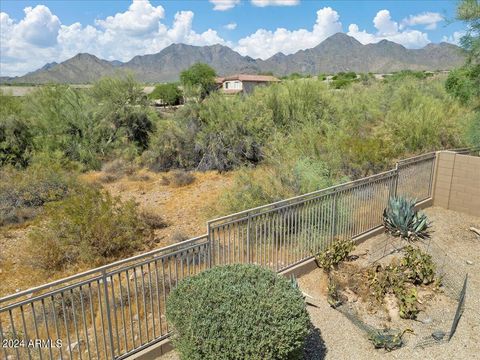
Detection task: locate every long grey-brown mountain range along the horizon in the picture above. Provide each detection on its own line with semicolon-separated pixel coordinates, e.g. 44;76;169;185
1;33;465;84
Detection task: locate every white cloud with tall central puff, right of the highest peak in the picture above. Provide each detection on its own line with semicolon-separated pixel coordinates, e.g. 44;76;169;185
347;10;430;48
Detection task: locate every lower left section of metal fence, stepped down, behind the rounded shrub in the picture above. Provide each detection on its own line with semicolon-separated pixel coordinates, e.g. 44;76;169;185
0;235;210;360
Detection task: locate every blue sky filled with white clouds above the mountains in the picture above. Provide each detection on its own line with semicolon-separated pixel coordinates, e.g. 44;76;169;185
0;0;465;76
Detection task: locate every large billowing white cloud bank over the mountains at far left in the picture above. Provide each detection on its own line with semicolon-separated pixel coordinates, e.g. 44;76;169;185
0;0;231;76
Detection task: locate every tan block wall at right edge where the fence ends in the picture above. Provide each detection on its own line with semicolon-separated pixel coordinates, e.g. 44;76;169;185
433;152;480;216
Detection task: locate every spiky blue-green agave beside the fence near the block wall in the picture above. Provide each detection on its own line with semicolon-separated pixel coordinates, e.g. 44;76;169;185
383;197;430;241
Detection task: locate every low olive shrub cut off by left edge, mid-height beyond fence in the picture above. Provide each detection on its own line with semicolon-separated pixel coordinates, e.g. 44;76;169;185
0;163;79;226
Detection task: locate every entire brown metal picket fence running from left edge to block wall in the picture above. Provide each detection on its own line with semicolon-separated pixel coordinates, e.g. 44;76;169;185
0;153;436;360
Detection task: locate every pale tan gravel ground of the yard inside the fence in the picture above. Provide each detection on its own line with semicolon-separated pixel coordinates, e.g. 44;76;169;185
161;207;480;360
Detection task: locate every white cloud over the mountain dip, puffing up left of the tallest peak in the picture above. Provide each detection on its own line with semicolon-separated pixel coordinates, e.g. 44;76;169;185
234;7;342;59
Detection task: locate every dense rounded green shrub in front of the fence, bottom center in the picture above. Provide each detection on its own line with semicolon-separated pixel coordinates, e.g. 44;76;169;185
167;264;309;359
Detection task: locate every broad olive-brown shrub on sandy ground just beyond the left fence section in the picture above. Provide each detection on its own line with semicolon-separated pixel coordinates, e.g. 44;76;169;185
29;187;152;269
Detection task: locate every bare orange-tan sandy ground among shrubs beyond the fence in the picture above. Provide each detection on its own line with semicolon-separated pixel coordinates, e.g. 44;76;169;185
0;170;233;296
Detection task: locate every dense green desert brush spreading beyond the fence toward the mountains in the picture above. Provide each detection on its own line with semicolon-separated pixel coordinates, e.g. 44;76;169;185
0;1;480;292
